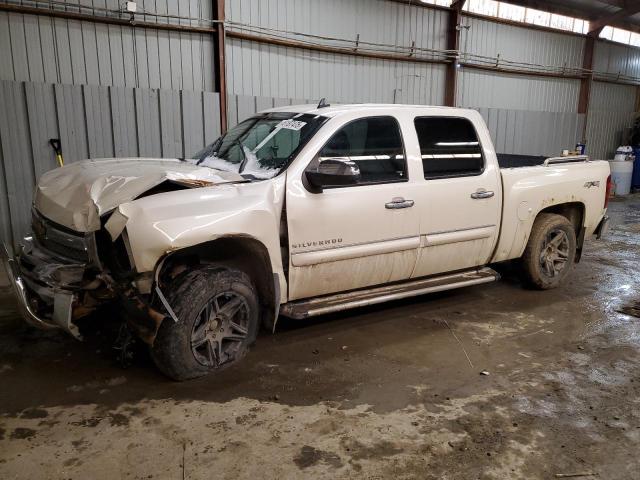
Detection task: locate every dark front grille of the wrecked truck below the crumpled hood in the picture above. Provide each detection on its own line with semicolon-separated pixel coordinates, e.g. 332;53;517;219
31;210;90;262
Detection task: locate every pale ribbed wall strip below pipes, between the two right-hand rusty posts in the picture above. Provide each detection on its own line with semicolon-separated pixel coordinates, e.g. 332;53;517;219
457;68;580;112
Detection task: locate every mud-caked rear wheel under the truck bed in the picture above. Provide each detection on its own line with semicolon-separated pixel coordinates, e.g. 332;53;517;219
522;213;576;290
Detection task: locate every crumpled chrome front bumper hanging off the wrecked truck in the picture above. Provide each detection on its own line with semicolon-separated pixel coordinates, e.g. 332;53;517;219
0;240;84;338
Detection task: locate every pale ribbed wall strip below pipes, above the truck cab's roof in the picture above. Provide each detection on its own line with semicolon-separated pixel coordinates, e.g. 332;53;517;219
227;38;445;105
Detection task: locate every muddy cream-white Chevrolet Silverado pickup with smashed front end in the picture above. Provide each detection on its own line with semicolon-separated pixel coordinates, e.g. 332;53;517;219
0;102;609;380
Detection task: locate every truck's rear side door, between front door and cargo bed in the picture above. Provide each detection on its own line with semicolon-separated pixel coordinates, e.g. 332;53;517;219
413;116;502;277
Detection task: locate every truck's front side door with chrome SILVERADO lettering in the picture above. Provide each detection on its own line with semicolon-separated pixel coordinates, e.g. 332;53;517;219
286;115;420;300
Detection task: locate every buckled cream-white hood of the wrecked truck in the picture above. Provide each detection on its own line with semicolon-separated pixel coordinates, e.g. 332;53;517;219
34;158;244;232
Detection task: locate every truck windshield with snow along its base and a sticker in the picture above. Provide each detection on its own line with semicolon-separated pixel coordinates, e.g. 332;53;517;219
189;112;326;180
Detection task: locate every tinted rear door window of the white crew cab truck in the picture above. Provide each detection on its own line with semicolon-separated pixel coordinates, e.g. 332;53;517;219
414;117;484;179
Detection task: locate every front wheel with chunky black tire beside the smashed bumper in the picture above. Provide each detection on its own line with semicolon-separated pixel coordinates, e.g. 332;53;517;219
151;266;260;381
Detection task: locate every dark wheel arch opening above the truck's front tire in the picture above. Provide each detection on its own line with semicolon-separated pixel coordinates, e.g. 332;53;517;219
154;235;280;329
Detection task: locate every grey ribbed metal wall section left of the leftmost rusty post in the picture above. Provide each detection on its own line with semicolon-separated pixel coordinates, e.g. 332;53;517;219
0;0;221;241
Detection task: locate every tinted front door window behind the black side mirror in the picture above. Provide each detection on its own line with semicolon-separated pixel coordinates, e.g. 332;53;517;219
320;117;407;184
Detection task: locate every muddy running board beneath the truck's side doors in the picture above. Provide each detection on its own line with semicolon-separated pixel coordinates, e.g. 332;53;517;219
280;267;500;319
